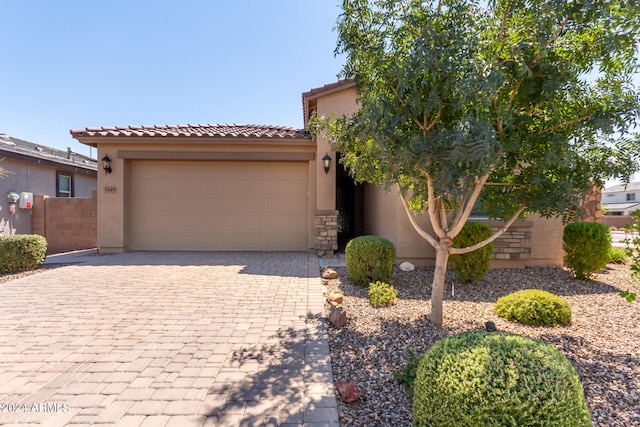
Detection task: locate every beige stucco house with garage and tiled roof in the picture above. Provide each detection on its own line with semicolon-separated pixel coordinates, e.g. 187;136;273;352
71;82;563;267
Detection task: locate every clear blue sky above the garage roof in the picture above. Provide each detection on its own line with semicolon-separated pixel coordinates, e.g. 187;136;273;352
0;0;342;156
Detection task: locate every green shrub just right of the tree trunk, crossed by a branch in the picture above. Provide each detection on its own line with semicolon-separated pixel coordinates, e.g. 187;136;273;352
449;222;493;282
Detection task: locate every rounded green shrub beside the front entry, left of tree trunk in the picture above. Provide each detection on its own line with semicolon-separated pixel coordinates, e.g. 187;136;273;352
345;236;396;286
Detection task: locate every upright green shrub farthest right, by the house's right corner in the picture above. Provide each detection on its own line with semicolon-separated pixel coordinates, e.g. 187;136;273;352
562;222;611;280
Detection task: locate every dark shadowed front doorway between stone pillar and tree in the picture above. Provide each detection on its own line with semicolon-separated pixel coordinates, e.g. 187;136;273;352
336;153;364;250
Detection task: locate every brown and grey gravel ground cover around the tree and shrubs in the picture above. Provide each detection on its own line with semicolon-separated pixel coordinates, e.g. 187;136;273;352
326;265;640;427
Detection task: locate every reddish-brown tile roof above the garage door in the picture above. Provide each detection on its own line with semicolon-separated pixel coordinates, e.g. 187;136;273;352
71;124;311;139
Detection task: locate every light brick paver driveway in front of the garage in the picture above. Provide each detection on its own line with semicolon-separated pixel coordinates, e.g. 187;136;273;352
0;252;338;426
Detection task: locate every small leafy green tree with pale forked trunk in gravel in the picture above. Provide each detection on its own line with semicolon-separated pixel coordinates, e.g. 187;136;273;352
324;0;640;324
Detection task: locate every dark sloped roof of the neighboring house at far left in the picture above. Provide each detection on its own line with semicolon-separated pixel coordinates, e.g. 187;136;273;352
0;133;97;171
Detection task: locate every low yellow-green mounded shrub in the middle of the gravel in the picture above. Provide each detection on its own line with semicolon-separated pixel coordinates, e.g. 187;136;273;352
494;289;571;326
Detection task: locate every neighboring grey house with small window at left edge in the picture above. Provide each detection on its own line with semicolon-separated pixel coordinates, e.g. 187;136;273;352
0;133;97;235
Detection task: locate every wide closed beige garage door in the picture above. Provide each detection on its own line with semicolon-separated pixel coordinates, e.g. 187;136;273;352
130;160;309;251
